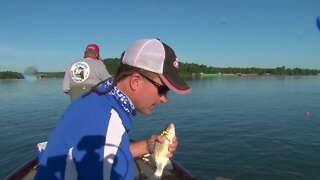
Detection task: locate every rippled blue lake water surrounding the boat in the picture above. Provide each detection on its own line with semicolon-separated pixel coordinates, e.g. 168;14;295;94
0;76;320;180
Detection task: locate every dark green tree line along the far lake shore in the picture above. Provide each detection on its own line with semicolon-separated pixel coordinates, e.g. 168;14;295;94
0;58;320;79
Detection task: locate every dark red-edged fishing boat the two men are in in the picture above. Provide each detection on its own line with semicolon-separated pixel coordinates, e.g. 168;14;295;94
5;143;196;180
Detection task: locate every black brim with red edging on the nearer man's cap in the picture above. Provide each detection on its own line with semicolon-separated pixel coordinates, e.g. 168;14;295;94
159;74;191;94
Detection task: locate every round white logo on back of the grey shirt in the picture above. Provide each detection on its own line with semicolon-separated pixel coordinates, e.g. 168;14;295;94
70;62;90;83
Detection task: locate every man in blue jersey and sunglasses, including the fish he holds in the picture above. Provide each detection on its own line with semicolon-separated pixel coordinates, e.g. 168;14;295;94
35;39;191;179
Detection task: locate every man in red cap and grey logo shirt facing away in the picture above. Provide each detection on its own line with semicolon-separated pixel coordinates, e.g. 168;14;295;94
62;44;110;100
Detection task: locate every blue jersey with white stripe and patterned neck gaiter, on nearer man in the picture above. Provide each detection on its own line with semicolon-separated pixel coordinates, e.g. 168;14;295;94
35;79;136;180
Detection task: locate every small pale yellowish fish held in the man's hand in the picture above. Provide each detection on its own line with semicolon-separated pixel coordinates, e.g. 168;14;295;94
153;122;175;179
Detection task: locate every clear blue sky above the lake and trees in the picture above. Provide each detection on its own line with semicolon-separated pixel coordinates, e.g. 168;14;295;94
0;0;320;72
